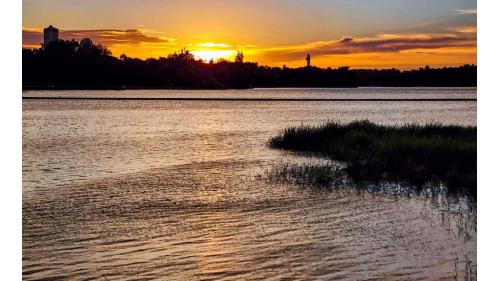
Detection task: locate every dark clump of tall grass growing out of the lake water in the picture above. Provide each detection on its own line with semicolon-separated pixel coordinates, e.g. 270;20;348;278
268;120;477;198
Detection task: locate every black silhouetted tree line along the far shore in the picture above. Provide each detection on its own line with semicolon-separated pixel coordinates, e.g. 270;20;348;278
22;40;477;89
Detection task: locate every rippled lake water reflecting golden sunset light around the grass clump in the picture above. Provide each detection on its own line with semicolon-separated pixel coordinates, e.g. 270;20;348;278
23;88;476;280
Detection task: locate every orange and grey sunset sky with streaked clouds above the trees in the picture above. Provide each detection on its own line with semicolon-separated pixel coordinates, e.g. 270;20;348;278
23;0;477;69
